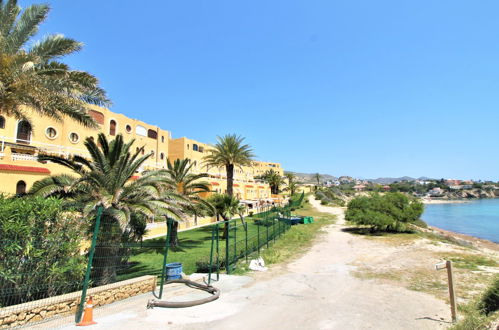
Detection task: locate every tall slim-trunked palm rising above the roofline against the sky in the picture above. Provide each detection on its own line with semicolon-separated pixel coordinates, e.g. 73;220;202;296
204;134;255;197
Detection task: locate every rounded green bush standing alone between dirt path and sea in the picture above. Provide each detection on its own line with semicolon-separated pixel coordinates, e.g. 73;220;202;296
345;193;424;232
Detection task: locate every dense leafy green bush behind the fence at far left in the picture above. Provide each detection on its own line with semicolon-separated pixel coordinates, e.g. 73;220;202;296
0;196;86;307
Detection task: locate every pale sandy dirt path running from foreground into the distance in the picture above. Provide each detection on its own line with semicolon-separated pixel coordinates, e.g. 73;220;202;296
64;199;449;330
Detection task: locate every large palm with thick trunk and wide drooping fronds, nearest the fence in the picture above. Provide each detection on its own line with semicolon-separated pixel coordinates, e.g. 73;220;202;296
30;133;183;284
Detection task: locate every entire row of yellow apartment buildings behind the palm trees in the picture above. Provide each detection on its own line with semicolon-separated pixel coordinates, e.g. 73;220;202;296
0;107;283;207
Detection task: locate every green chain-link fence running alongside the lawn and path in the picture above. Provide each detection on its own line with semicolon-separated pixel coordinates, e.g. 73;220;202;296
0;194;304;327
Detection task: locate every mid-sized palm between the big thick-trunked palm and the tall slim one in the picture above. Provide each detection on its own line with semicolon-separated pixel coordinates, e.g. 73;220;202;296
166;159;212;247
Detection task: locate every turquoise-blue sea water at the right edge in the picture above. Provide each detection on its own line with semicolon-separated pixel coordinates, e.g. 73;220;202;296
421;199;499;243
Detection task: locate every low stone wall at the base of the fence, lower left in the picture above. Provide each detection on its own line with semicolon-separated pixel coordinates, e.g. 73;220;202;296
0;275;156;329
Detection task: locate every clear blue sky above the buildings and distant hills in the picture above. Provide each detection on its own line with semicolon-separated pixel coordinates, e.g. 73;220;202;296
25;0;499;180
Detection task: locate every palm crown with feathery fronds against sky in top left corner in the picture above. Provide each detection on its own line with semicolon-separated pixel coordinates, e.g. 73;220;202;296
0;0;110;126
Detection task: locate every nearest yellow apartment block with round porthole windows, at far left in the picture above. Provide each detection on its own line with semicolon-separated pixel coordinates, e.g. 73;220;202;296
0;107;171;194
